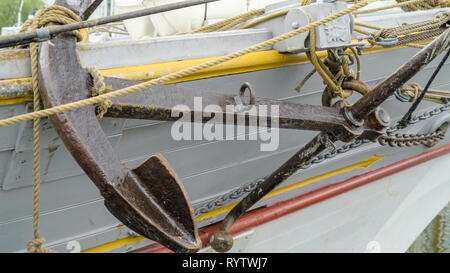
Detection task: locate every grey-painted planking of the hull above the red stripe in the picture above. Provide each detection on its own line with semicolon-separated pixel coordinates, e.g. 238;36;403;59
0;4;450;252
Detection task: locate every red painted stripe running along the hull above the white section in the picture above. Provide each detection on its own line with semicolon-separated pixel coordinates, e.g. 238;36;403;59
135;144;450;253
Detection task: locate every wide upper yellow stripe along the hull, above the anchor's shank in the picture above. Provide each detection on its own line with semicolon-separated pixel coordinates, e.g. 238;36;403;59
0;44;403;105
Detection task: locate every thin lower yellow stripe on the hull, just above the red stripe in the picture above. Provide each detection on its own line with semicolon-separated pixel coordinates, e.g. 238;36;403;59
82;155;385;253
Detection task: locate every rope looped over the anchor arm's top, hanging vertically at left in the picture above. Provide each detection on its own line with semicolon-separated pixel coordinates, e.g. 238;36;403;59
20;6;83;253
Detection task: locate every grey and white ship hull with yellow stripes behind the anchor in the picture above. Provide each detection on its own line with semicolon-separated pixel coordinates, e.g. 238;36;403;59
0;6;450;252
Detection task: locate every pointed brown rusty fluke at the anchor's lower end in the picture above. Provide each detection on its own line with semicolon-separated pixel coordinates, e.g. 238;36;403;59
105;154;201;252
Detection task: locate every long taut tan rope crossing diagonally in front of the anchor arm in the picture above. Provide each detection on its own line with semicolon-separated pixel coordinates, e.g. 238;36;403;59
0;0;373;127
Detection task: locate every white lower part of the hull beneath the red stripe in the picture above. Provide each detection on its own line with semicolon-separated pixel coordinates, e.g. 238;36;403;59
202;152;450;253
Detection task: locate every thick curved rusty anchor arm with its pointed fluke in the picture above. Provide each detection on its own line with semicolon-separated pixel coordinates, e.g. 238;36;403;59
39;0;201;252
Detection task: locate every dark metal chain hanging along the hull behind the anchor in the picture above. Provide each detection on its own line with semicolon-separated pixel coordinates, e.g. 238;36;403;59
195;103;450;217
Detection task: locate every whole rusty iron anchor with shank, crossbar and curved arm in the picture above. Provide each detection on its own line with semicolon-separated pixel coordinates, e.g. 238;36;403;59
31;0;450;252
